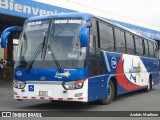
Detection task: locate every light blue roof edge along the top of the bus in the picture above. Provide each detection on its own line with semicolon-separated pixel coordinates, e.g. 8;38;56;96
25;12;156;43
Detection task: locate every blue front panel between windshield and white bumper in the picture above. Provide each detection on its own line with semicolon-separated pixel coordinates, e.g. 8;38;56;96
14;68;88;81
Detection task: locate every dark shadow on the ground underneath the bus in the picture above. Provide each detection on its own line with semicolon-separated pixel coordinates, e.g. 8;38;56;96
17;86;156;111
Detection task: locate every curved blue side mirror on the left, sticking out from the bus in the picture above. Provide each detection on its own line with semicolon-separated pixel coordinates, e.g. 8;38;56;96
1;26;22;48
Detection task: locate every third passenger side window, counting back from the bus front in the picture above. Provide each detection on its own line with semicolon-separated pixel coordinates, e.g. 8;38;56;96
126;32;135;54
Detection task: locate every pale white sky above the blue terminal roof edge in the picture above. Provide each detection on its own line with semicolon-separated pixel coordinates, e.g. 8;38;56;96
36;0;160;28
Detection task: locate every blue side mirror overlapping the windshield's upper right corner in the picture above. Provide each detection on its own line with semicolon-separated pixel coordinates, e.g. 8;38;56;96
80;22;91;47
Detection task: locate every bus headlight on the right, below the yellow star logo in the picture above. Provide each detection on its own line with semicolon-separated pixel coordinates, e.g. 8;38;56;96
62;79;86;90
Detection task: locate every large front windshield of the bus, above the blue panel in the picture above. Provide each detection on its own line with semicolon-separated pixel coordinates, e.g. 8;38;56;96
15;19;86;69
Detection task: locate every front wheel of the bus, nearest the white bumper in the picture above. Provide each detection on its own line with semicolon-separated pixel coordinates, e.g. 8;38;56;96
99;80;115;105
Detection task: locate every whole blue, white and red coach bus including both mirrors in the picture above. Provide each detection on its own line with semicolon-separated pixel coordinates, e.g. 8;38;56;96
1;12;159;104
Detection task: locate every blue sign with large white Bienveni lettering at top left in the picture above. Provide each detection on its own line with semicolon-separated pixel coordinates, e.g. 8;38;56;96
0;0;73;18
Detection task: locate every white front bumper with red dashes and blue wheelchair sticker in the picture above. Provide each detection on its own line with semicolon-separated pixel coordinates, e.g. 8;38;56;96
13;79;88;102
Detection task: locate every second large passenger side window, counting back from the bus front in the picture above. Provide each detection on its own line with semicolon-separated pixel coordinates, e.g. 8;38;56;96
115;29;126;53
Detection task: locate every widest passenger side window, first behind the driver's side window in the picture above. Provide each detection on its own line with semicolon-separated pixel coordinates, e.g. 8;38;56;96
99;23;114;51
